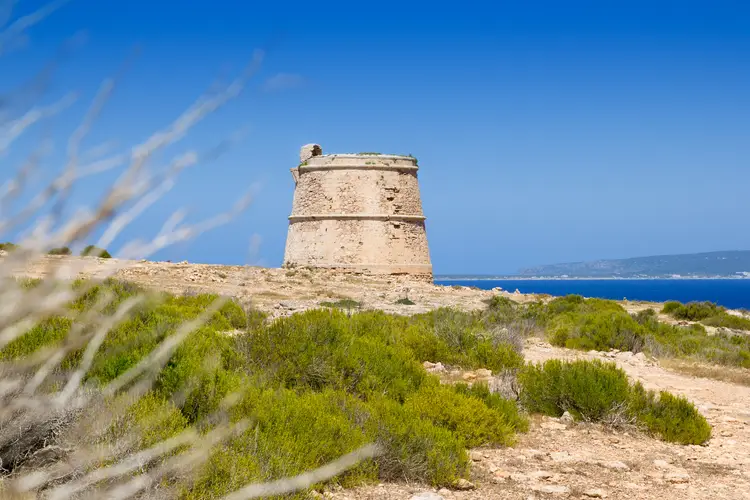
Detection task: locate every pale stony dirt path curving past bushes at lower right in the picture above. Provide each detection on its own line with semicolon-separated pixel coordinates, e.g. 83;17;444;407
331;339;750;500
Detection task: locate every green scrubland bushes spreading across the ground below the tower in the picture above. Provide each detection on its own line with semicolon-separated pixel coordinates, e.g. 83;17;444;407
0;281;724;498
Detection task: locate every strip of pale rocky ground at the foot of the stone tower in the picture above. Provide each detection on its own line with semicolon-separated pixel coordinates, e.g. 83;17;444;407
10;256;656;319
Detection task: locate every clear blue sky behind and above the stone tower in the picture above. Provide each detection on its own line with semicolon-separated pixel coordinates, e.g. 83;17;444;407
0;0;750;273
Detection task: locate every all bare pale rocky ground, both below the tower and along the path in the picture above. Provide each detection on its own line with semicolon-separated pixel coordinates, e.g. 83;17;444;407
5;257;750;500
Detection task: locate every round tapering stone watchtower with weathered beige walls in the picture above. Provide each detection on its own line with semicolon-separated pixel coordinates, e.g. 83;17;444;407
284;144;432;279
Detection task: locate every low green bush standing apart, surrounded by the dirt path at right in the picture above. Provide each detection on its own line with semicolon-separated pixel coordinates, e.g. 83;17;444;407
519;360;711;444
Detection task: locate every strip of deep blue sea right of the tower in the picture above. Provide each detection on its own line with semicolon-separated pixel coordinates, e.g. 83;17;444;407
435;279;750;309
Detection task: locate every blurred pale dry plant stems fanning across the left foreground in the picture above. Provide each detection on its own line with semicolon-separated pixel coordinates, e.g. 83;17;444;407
0;5;378;500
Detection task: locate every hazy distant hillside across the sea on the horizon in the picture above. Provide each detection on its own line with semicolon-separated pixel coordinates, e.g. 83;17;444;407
519;250;750;278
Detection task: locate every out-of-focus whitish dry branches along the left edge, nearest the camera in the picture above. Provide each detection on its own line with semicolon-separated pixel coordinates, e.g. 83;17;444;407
0;1;377;500
